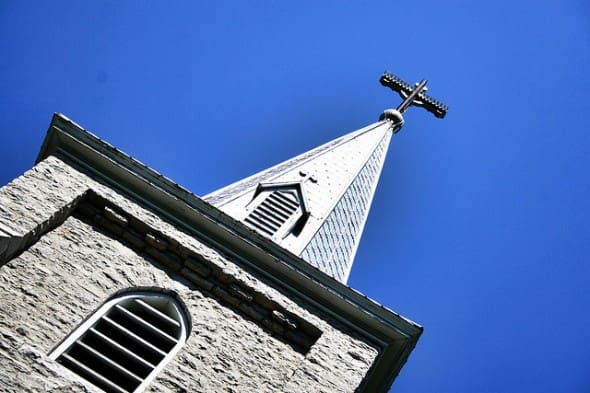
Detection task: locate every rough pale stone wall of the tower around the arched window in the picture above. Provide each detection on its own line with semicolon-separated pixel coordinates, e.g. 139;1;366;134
0;157;377;392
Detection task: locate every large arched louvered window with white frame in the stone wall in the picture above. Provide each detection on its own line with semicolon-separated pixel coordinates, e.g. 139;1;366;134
50;291;189;392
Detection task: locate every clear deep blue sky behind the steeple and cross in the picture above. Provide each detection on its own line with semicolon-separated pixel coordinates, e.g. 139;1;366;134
0;0;590;393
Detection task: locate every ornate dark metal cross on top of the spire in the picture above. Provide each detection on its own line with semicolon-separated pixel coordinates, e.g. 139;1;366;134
379;72;449;119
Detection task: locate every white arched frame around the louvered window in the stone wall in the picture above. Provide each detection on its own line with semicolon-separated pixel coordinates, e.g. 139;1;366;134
49;289;191;393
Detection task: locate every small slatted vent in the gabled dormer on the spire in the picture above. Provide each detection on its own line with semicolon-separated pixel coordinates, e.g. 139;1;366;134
244;190;301;236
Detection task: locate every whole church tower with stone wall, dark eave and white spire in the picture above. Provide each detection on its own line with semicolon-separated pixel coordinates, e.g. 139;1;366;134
0;114;422;392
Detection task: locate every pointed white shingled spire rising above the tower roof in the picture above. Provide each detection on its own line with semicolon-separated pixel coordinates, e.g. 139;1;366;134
203;121;393;282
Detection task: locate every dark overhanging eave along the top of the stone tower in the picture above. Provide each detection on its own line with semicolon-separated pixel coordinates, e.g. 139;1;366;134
37;114;423;392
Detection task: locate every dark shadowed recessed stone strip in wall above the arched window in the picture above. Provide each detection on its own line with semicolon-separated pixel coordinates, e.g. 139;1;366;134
74;192;322;353
